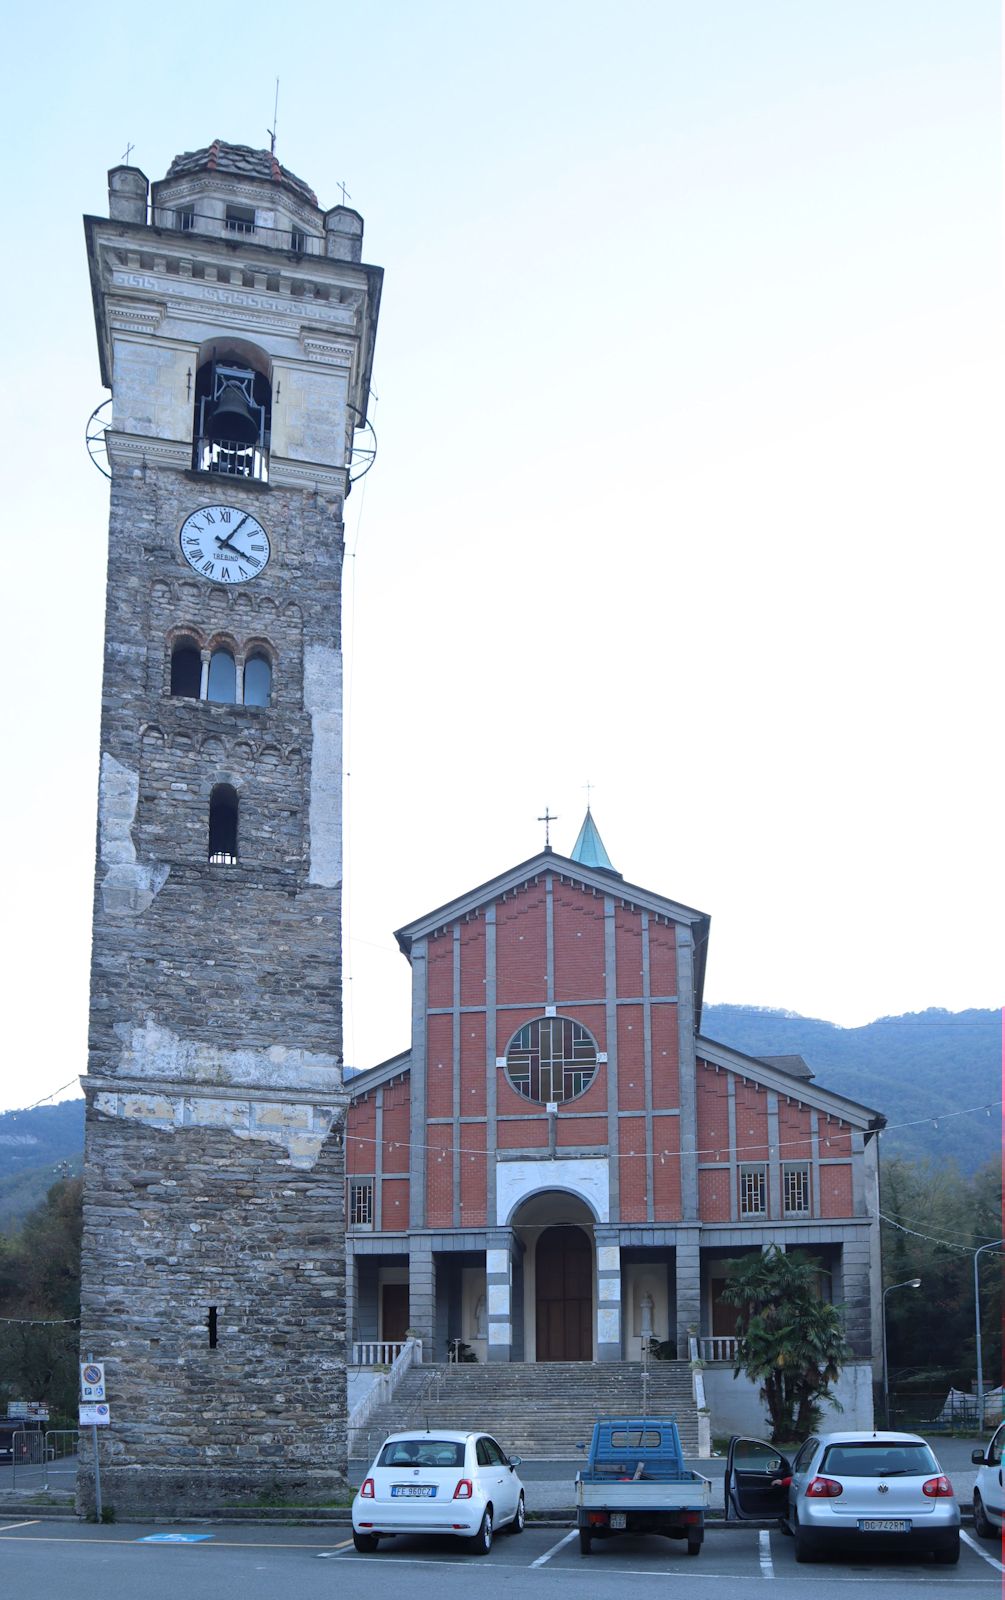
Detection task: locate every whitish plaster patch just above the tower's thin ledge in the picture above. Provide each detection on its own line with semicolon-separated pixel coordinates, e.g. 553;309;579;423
115;1018;342;1099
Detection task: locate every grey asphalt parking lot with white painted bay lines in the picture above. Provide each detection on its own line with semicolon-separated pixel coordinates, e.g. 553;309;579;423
0;1517;1005;1600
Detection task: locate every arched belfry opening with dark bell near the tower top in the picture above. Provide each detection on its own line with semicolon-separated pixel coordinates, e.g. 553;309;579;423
192;339;272;482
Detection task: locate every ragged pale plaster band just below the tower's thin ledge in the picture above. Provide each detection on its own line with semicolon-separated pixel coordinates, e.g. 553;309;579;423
94;1090;334;1171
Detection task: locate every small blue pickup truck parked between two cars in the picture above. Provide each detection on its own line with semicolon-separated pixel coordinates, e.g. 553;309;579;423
576;1416;712;1555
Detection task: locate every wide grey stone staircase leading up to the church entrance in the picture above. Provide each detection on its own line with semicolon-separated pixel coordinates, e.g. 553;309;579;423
354;1362;698;1461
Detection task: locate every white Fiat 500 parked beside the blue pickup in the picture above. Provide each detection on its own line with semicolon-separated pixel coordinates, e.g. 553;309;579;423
352;1429;525;1555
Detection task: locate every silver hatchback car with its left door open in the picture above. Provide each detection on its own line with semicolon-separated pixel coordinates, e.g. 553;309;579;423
725;1430;960;1566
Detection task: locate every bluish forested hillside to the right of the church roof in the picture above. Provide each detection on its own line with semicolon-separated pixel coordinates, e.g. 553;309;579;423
701;1005;1002;1173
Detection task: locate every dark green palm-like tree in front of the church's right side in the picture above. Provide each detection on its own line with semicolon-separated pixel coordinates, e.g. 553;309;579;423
722;1245;851;1445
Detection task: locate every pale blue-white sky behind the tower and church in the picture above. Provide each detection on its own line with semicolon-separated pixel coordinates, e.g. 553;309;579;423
0;0;1005;1107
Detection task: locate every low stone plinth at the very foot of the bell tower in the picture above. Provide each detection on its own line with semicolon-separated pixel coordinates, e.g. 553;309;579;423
75;1465;347;1522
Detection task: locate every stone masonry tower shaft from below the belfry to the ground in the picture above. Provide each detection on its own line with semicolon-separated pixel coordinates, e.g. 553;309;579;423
78;457;346;1514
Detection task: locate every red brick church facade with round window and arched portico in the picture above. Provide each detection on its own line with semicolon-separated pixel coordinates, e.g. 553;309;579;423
346;813;882;1362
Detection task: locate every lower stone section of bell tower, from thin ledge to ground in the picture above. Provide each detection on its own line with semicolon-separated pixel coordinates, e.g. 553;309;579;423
77;1088;346;1518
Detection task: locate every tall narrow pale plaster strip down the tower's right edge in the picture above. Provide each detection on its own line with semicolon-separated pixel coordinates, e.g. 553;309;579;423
304;645;342;888
